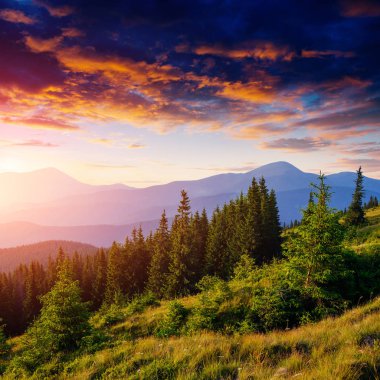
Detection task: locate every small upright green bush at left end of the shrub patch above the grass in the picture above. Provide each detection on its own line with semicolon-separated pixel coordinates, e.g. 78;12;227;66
156;301;188;338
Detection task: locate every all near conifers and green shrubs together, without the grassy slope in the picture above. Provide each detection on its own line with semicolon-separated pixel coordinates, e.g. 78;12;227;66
0;168;380;374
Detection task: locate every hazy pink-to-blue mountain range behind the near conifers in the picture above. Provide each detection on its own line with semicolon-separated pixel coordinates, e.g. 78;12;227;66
0;162;380;247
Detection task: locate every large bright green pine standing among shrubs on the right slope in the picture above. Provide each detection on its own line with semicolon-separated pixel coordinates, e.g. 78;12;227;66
284;174;344;302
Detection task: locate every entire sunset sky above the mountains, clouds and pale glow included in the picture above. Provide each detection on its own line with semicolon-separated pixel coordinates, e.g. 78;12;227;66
0;0;380;187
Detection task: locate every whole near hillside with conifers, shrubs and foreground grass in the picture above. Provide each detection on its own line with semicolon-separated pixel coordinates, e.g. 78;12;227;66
0;169;380;379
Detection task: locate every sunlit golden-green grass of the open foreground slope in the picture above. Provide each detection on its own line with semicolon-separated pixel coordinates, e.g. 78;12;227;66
3;208;380;380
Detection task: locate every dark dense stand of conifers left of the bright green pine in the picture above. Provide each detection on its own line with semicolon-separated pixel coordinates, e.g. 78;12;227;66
0;178;281;334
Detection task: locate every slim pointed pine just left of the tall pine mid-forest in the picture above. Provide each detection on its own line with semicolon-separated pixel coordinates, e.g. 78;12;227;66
147;210;171;298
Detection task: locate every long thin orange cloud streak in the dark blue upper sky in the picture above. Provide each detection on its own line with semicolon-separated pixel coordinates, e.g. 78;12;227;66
194;41;296;61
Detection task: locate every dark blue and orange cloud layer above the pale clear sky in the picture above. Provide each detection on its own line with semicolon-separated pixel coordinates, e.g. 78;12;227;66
0;0;380;178
